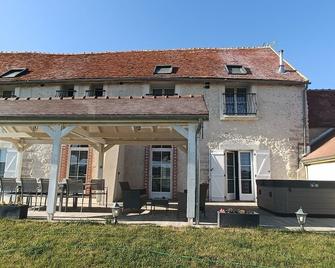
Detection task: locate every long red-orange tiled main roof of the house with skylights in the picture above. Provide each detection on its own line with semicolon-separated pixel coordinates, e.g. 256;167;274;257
0;47;306;83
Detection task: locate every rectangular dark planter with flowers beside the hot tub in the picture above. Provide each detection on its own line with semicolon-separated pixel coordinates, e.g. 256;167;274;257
218;208;259;227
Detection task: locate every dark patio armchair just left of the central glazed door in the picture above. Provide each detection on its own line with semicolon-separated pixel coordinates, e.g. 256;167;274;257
119;181;148;210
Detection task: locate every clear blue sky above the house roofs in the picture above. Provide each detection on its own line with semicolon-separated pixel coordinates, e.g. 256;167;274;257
0;0;335;88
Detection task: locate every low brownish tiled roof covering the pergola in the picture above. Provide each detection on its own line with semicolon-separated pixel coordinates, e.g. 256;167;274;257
0;95;208;122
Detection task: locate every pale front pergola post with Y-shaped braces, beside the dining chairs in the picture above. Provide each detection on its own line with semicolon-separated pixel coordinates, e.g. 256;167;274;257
41;125;75;221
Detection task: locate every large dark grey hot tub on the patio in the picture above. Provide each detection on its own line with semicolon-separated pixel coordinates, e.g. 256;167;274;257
256;180;335;216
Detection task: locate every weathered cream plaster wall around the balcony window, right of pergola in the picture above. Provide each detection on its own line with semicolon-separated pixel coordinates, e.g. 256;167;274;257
176;83;303;181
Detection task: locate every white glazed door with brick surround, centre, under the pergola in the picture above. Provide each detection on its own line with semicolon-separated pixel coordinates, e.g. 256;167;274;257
149;146;172;199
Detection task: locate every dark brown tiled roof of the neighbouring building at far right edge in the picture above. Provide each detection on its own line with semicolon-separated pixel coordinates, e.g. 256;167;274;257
307;90;335;128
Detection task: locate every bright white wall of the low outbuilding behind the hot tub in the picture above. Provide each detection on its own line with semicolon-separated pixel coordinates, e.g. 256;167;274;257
306;162;335;181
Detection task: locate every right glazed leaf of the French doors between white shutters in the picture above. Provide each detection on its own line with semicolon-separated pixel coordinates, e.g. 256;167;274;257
239;151;255;201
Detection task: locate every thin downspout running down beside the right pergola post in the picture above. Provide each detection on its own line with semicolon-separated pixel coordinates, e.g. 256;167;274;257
195;120;203;225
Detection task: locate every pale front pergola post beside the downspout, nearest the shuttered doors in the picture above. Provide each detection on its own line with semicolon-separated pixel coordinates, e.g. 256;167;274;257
186;124;197;224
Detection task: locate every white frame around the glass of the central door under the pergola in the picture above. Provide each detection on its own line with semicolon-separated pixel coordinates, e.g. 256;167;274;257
149;147;173;199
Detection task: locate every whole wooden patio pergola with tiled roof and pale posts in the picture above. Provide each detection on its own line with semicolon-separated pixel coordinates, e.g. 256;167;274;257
0;96;208;223
